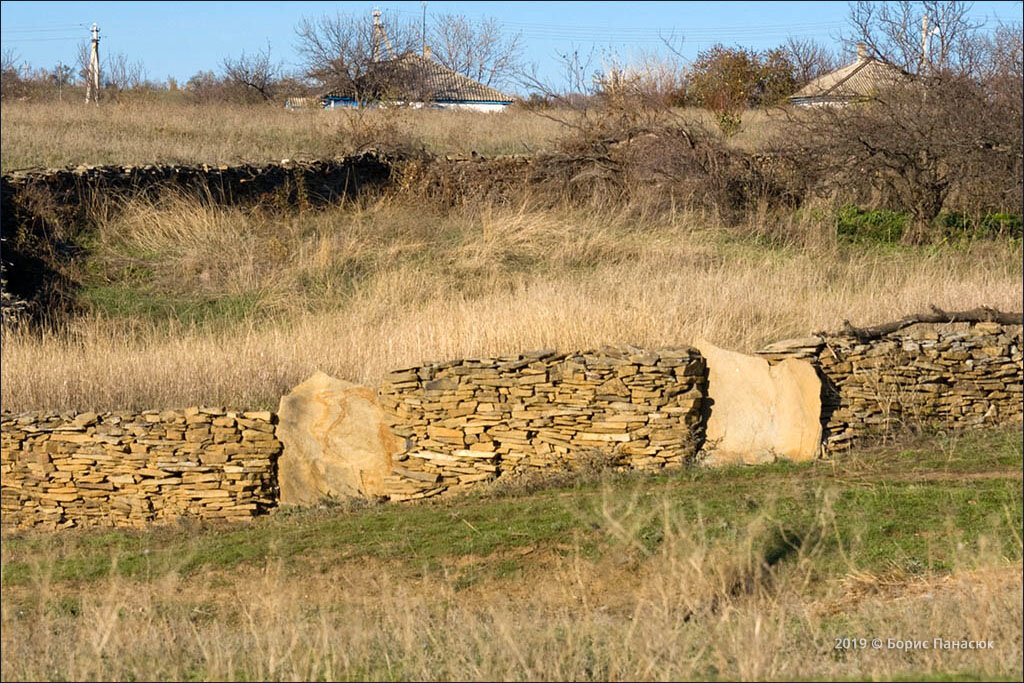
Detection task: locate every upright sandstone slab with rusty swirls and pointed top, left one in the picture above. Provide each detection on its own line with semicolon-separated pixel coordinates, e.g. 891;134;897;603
278;372;403;506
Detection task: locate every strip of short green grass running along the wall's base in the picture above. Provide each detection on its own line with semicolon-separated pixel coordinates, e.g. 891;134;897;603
3;429;1024;586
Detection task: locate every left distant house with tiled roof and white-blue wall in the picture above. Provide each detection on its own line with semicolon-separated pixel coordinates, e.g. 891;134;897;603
322;52;513;112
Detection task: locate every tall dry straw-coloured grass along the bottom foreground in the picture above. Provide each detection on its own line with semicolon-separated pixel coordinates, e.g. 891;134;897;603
0;493;1024;681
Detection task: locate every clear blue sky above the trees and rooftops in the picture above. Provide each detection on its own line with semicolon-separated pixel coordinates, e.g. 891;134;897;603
0;0;1021;91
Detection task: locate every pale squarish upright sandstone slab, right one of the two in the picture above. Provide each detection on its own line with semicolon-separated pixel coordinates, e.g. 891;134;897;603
695;339;821;464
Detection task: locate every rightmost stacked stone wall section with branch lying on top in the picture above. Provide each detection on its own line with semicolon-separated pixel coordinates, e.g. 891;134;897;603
761;323;1024;452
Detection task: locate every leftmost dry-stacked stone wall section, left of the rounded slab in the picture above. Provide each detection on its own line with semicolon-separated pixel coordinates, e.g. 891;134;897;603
0;408;281;528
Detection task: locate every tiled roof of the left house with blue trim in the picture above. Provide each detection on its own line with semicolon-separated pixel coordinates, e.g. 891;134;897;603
324;52;513;102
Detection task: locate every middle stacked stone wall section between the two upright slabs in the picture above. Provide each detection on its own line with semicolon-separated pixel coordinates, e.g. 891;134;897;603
380;347;707;500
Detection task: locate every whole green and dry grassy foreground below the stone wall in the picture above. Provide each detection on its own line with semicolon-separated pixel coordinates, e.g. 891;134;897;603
0;428;1024;680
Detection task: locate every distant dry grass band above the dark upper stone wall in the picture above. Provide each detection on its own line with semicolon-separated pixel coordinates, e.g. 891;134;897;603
0;101;562;171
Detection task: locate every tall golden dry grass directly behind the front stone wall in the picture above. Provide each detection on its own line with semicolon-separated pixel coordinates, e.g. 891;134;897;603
0;198;1022;411
